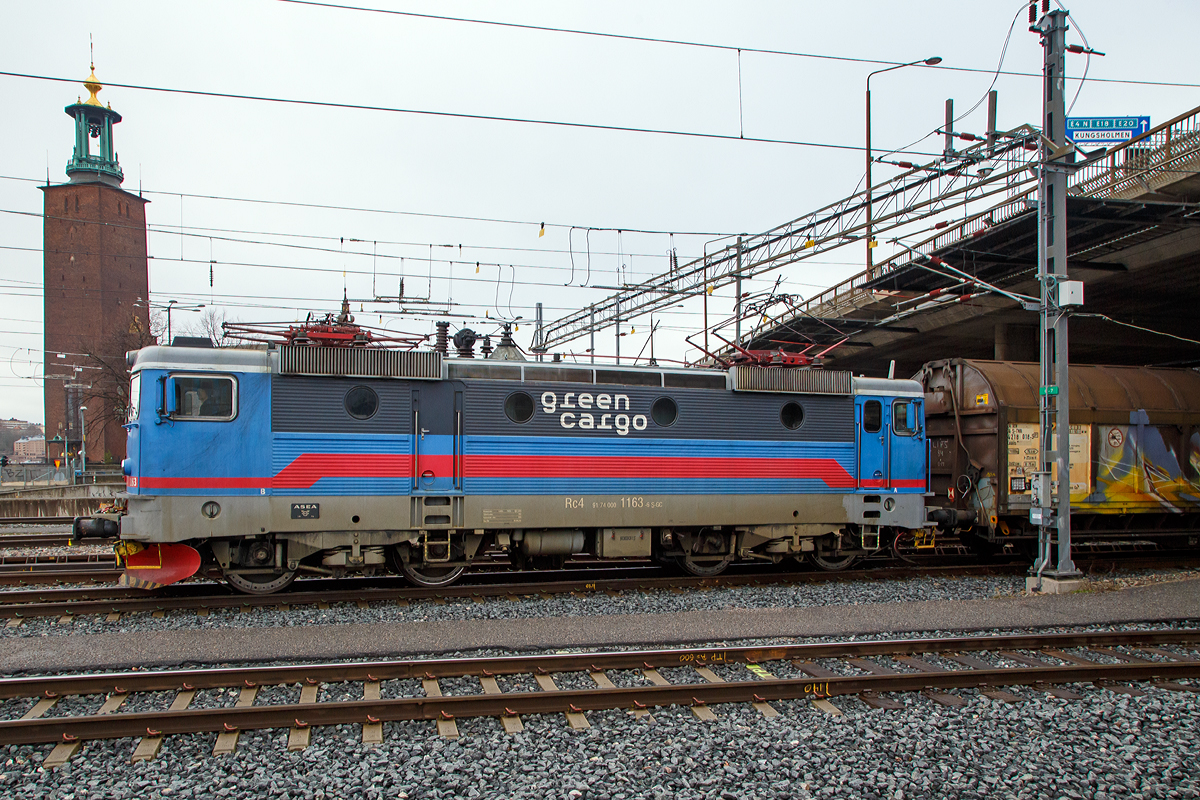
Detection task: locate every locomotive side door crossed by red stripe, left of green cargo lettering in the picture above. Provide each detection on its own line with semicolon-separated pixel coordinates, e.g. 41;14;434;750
412;381;463;495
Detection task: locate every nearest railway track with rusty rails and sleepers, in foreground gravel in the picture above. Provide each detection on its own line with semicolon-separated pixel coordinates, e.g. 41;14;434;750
0;630;1200;768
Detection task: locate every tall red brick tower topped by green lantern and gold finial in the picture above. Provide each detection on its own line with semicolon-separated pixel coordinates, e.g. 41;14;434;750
42;65;152;463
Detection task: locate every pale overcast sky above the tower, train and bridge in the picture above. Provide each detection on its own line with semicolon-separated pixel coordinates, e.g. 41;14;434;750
0;0;1200;421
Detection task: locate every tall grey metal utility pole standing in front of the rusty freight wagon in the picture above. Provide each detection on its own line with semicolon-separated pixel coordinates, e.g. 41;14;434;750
1027;4;1081;593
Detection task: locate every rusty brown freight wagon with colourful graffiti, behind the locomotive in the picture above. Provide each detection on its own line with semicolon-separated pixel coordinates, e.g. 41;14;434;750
916;359;1200;548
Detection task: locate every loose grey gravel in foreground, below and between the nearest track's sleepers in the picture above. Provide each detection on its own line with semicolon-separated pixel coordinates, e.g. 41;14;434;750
0;621;1200;800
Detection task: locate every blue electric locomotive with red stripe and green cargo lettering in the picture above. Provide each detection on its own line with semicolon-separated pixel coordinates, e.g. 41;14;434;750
76;331;940;594
